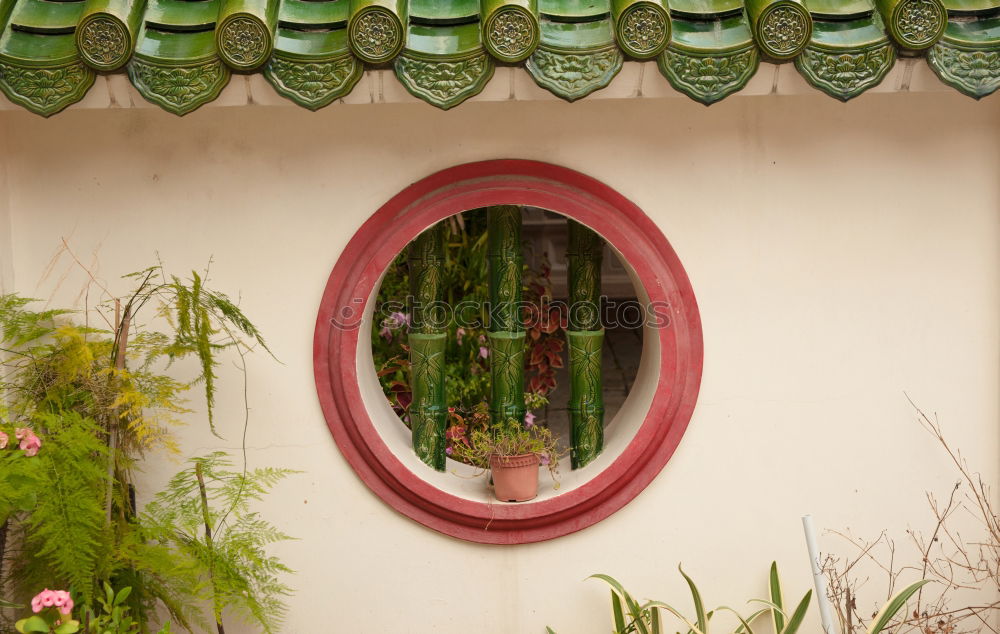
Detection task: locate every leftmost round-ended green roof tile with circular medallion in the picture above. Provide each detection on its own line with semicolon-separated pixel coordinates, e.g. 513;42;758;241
76;0;146;71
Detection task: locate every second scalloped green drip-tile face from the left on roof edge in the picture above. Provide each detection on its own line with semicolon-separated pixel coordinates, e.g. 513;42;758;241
127;58;229;115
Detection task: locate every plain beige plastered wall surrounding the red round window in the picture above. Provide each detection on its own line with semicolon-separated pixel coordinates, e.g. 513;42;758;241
0;93;1000;634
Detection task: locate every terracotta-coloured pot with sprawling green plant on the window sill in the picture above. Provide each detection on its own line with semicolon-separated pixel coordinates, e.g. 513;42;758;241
452;418;560;502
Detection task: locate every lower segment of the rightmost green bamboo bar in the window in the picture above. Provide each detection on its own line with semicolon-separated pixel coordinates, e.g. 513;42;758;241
566;329;604;469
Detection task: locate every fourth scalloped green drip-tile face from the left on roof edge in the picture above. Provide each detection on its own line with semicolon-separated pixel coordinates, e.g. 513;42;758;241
395;52;493;110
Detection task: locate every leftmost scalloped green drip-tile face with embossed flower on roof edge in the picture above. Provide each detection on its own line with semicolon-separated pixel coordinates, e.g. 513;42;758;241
0;60;94;117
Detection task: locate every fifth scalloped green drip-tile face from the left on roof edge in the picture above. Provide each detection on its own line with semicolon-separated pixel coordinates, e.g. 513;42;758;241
525;46;625;101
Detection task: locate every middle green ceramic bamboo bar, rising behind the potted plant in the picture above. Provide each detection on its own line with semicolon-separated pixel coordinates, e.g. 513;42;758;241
486;205;525;425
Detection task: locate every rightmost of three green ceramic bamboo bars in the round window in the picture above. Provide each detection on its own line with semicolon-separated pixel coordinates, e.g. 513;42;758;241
566;220;604;469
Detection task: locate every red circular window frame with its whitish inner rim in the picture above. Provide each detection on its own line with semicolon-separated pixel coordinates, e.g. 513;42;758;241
314;160;702;544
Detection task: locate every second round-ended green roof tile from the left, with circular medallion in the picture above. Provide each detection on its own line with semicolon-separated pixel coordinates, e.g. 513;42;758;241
215;0;278;70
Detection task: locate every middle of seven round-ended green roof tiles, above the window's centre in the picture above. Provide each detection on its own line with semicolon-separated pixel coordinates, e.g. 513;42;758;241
479;0;541;63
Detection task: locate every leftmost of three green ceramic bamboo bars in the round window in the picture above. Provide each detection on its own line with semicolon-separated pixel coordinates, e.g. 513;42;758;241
408;224;448;471
